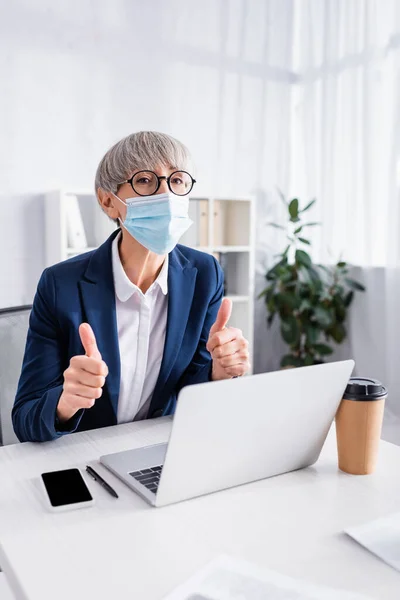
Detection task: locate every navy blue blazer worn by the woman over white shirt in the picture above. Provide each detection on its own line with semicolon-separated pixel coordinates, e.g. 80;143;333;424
12;230;223;442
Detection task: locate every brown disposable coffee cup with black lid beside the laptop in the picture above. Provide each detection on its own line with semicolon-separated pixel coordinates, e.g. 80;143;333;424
336;377;387;475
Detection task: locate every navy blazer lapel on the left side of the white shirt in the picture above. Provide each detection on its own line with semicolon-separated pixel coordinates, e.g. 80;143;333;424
79;230;121;415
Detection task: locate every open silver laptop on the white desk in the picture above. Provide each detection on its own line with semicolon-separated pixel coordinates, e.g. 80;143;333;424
100;360;354;506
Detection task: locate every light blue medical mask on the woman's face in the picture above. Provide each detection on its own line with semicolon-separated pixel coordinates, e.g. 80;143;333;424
113;193;193;254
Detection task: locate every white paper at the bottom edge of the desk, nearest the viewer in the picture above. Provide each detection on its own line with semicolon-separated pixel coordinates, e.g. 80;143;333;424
164;556;368;600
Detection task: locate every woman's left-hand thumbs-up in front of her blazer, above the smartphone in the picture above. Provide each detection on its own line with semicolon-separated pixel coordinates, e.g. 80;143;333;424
57;323;108;422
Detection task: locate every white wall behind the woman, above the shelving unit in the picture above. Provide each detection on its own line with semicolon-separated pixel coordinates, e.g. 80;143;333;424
0;0;294;341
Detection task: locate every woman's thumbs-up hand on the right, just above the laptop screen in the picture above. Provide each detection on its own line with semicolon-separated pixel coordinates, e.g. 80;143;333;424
207;298;250;381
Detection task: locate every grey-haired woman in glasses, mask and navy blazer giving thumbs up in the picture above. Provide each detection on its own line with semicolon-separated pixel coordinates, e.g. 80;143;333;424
12;132;249;441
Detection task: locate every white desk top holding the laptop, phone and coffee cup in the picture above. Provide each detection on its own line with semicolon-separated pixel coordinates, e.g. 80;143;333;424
0;418;400;600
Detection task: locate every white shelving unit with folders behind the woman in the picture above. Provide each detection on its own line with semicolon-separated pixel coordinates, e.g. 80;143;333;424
45;190;255;370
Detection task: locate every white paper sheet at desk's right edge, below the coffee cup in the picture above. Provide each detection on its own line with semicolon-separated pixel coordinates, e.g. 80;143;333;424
346;513;400;571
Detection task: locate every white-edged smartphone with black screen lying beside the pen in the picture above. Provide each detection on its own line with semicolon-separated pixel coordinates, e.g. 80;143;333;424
41;469;94;511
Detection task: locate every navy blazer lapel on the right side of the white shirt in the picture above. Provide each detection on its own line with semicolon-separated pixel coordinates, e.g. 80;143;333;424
149;248;197;414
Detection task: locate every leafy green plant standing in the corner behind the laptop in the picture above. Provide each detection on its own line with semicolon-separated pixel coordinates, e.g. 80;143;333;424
259;194;365;367
